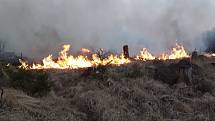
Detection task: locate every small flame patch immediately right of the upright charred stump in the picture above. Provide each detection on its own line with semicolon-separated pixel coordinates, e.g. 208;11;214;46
135;48;155;61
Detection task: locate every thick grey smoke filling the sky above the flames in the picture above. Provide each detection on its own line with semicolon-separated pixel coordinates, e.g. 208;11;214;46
0;0;215;57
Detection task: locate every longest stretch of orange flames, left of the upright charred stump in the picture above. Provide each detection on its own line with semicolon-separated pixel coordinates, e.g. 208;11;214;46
20;45;130;69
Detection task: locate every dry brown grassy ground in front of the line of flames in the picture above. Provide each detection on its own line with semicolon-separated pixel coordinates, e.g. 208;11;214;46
0;60;215;121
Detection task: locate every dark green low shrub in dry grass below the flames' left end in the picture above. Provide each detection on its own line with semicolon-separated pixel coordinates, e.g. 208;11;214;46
6;69;52;97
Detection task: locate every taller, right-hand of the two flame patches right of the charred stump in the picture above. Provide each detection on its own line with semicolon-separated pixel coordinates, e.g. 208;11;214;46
158;43;190;60
